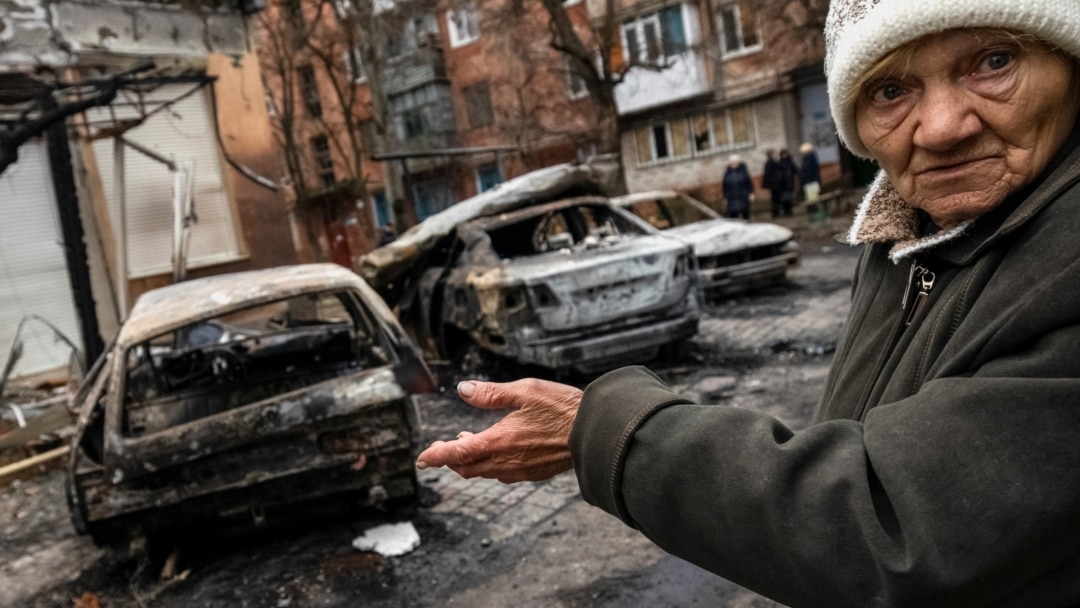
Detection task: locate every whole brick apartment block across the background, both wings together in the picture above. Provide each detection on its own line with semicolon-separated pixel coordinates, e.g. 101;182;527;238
254;0;840;266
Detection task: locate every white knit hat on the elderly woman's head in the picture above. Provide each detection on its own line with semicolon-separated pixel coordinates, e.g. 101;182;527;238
825;0;1080;157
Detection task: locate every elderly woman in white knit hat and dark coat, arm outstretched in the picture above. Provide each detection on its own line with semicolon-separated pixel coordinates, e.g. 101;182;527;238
419;0;1080;607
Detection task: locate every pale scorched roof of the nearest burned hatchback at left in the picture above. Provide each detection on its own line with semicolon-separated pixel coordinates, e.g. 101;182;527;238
117;264;366;347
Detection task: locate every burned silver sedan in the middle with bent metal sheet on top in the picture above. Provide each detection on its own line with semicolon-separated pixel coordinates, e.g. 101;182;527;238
360;159;701;374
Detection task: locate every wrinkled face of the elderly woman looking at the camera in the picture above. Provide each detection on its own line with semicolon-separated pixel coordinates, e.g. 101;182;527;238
855;29;1080;227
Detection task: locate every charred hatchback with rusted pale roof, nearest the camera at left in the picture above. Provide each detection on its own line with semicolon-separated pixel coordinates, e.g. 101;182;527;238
67;265;435;540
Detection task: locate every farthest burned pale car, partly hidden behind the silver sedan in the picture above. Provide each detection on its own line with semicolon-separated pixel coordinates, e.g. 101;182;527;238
611;190;801;298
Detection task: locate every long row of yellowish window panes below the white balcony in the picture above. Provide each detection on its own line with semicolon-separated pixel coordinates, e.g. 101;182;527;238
634;104;754;165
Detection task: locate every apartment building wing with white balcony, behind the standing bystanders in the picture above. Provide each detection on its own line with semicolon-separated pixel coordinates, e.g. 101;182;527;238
597;0;840;208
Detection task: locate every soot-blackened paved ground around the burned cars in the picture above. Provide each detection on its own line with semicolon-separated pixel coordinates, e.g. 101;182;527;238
0;234;856;608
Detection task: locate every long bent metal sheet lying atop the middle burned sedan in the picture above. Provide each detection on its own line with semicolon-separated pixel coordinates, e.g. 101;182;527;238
360;156;618;289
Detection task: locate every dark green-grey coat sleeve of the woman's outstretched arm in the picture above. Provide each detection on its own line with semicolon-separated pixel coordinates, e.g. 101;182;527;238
571;356;1080;607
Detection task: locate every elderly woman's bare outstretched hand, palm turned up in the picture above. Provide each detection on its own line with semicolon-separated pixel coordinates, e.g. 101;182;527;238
417;378;582;484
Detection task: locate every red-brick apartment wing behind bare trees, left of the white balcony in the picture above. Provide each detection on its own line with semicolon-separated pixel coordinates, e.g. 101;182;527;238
259;0;595;257
